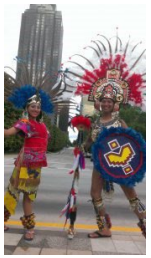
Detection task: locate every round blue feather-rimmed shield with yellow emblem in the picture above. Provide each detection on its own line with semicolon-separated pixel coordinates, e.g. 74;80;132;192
92;127;146;187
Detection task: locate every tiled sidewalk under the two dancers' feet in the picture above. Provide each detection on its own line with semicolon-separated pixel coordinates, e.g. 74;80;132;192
4;226;146;255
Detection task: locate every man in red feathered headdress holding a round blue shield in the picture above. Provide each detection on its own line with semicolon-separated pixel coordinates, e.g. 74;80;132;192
61;31;146;238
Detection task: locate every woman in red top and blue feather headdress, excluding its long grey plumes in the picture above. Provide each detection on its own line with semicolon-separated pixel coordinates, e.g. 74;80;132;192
4;81;53;240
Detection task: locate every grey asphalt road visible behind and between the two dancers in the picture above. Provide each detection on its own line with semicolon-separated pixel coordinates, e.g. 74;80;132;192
4;148;146;228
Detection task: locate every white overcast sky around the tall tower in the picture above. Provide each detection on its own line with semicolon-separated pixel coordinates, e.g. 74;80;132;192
4;4;146;70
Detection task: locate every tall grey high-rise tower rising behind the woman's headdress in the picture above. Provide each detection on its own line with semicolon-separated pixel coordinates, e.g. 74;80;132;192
17;4;63;89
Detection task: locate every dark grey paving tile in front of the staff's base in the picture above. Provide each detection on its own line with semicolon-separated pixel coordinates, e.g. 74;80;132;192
67;237;92;251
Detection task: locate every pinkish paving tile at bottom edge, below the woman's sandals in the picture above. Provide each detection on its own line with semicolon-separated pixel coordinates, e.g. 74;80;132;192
13;247;41;255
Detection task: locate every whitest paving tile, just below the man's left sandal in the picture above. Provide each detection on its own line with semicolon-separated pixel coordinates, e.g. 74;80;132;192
91;238;116;252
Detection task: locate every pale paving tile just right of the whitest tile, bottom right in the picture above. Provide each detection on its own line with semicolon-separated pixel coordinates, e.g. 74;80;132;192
113;240;141;254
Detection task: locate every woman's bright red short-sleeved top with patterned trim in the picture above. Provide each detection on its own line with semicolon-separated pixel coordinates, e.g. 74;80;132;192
15;120;49;167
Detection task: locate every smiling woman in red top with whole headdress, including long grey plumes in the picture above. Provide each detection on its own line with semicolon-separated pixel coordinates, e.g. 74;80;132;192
4;56;78;240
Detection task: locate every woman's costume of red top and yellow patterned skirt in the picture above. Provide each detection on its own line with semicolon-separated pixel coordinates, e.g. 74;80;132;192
4;119;49;221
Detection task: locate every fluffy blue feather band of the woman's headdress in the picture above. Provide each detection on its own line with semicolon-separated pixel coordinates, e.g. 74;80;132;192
8;84;53;114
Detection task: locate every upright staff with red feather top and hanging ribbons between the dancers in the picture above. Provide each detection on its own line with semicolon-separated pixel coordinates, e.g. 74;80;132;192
61;115;91;239
